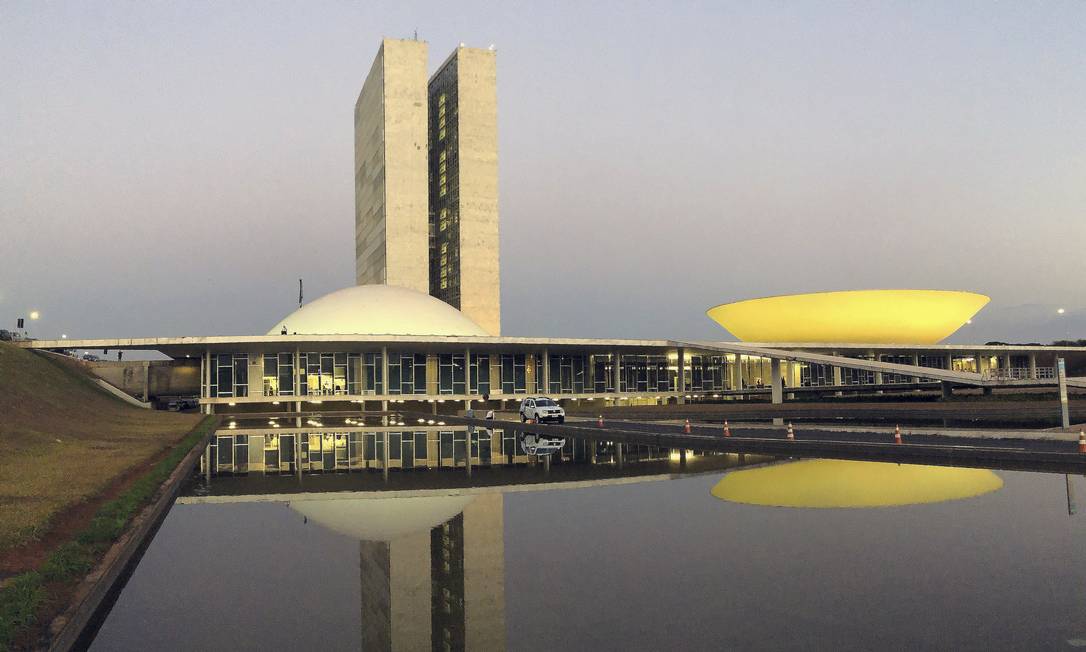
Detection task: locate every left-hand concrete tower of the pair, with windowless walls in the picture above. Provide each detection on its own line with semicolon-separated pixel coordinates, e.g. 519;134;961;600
354;39;430;293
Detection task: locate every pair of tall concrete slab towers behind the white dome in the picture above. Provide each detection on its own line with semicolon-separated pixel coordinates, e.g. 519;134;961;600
354;39;502;336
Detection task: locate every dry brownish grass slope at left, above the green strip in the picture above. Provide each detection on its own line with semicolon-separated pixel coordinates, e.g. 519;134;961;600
0;342;200;552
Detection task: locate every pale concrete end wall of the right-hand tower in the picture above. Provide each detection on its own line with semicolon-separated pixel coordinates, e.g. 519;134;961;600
456;48;502;336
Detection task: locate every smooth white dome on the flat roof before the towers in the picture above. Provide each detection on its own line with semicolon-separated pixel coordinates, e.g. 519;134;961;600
268;285;488;336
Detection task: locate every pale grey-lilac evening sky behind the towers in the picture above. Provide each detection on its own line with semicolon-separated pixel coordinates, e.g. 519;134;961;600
0;1;1086;341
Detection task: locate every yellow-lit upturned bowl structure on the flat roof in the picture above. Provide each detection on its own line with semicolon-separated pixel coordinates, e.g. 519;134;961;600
705;290;988;344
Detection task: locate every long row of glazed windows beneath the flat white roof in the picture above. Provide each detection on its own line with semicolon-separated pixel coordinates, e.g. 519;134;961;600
209;352;975;398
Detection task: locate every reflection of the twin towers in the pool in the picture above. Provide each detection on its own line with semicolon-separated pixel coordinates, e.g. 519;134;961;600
358;493;505;650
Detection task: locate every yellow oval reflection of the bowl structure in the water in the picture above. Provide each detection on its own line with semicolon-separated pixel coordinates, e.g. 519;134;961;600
712;460;1003;507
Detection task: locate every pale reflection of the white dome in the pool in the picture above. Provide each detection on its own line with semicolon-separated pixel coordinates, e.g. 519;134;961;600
290;496;473;541
